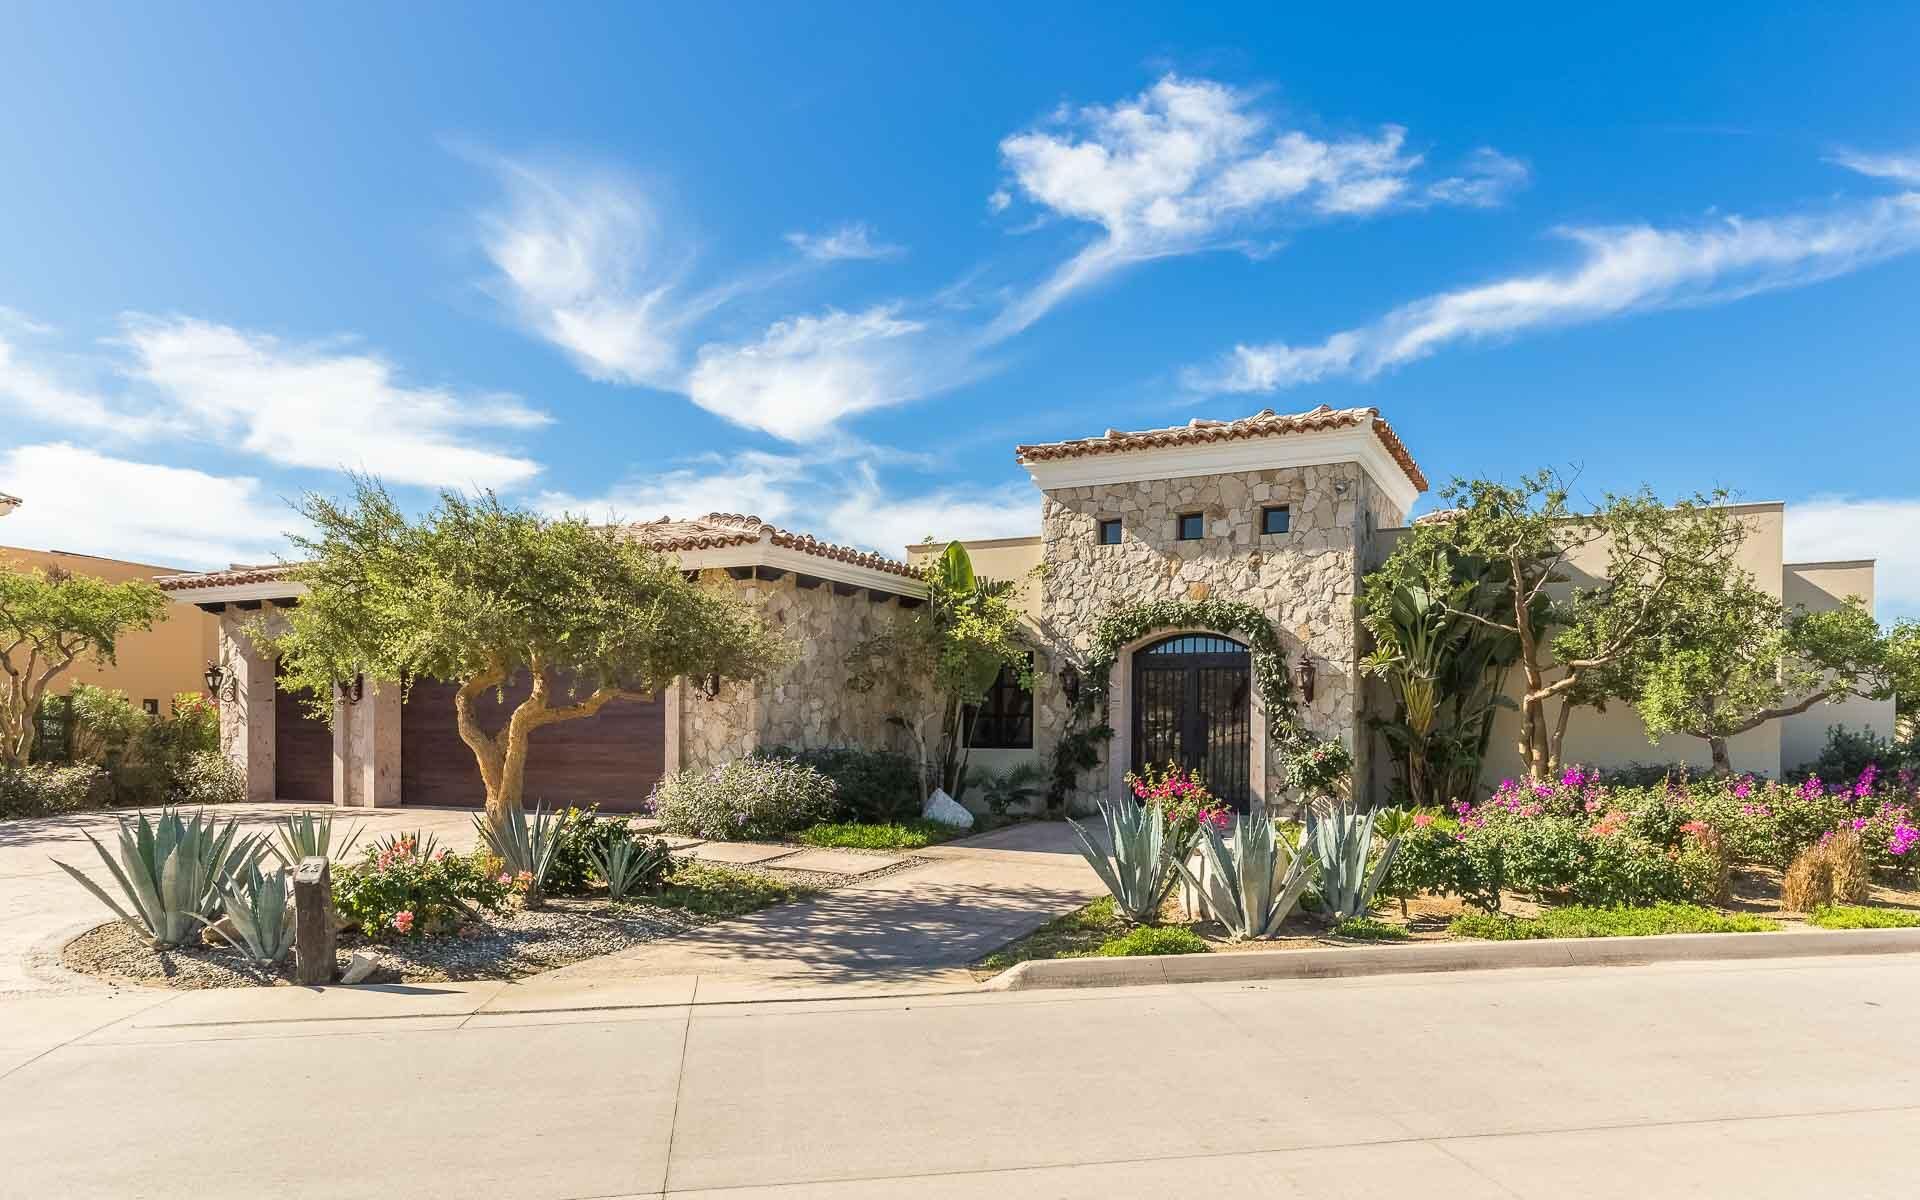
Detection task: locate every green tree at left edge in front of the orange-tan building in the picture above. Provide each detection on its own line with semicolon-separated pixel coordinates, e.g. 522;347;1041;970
0;566;169;766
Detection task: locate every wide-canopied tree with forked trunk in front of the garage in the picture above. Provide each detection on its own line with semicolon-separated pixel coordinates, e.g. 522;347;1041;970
269;476;785;824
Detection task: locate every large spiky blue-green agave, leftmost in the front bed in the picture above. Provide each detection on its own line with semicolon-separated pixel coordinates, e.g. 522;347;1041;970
54;808;265;948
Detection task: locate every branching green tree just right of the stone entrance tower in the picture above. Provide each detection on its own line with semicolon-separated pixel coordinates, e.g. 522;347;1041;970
1402;470;1745;780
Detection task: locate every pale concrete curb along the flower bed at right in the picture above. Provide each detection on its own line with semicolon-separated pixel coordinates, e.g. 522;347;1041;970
981;929;1920;991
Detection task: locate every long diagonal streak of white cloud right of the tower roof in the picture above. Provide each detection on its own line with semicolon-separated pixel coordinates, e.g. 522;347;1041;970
1187;194;1920;392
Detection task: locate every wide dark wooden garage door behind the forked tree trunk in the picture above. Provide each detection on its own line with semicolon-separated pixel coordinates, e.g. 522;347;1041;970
399;680;666;812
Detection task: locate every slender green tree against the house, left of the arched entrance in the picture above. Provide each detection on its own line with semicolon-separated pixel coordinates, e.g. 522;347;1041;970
849;541;1033;799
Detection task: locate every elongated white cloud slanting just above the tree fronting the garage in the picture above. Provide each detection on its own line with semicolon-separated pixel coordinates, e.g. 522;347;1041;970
121;317;549;488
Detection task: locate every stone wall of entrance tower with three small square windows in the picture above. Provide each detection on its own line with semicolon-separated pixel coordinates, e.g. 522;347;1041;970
1035;463;1400;806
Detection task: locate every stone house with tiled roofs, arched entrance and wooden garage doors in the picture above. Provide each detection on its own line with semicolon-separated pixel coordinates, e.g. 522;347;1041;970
161;407;1893;808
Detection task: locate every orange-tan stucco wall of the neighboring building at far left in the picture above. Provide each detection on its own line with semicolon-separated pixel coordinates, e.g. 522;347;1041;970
0;545;217;712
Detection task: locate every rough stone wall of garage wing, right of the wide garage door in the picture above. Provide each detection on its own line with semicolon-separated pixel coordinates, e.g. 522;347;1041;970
680;570;925;768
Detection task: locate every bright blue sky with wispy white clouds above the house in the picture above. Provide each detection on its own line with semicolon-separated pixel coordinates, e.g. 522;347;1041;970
0;4;1920;614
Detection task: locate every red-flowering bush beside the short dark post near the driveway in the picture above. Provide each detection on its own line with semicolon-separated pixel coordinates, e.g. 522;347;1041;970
334;835;515;937
